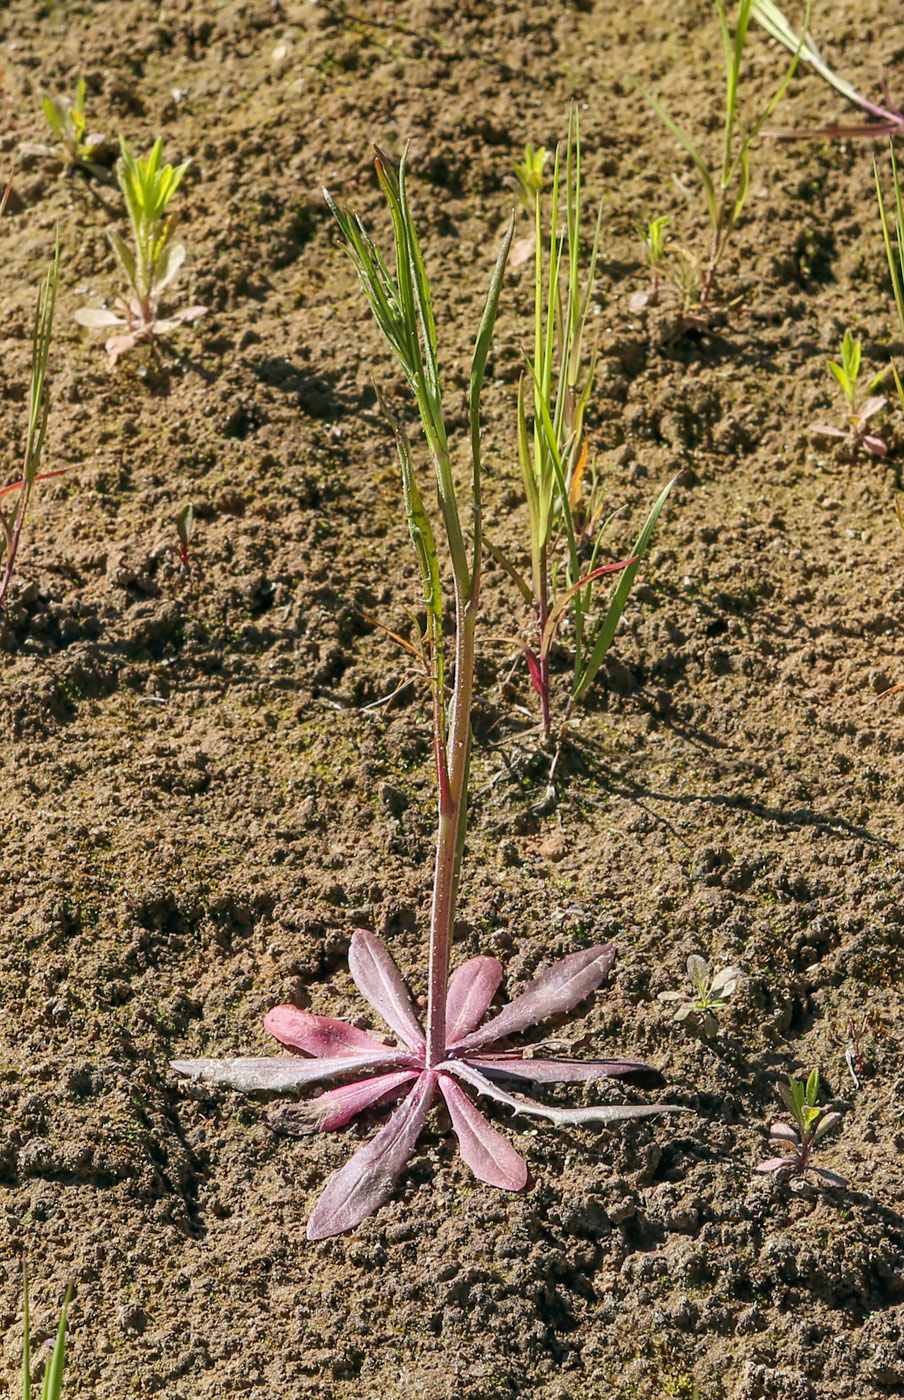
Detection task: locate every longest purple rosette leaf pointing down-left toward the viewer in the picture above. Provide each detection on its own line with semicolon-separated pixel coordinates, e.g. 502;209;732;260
308;1070;437;1239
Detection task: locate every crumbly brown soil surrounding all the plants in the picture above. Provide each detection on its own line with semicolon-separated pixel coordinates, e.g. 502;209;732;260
0;0;904;1400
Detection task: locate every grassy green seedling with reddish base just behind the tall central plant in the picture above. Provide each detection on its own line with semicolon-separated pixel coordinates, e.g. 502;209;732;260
487;108;675;746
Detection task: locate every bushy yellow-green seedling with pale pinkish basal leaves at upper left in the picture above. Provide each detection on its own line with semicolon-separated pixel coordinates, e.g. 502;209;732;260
76;137;207;361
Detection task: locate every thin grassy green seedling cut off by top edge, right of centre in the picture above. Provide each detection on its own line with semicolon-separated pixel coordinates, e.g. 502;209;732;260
635;0;810;314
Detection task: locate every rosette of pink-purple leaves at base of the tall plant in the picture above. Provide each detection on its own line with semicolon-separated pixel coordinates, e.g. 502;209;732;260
172;928;687;1239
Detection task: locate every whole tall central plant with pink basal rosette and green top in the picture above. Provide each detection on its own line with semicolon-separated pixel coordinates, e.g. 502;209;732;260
174;150;691;1239
